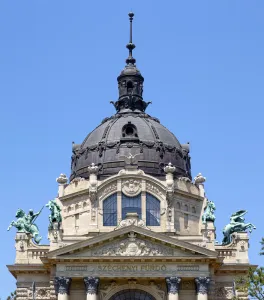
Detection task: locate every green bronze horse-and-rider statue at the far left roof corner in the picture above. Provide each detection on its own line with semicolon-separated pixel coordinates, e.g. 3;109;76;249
7;207;43;244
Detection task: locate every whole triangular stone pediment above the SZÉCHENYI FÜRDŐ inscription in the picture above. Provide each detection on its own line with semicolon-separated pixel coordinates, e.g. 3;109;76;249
48;225;217;259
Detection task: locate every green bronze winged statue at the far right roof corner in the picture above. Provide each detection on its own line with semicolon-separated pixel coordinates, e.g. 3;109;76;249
222;210;256;245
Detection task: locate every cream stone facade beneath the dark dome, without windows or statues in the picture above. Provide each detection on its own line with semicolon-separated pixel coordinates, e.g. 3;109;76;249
8;169;249;300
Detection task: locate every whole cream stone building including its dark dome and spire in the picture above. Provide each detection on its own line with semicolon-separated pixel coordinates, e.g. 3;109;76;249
8;13;254;300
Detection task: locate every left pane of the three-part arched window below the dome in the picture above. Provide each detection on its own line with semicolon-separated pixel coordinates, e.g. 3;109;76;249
103;194;117;226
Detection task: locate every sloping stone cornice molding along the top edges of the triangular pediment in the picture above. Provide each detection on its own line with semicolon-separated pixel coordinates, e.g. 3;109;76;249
47;225;217;258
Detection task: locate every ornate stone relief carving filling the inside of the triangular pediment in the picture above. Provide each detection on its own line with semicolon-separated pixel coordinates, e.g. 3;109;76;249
91;232;173;256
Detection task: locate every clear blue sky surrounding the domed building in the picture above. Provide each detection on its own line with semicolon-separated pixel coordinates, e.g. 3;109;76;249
0;0;264;299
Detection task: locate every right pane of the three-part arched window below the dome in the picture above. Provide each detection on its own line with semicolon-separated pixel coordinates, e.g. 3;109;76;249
146;193;160;226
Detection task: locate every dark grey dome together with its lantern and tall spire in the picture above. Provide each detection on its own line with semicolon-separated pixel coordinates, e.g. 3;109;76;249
70;13;191;180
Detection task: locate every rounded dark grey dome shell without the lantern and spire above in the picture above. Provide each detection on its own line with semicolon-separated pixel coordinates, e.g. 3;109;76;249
71;112;191;180
